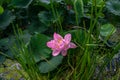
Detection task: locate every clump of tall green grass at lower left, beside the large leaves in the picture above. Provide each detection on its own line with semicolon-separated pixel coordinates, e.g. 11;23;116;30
11;25;46;80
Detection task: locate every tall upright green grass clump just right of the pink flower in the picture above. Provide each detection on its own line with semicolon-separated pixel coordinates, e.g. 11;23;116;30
59;0;104;80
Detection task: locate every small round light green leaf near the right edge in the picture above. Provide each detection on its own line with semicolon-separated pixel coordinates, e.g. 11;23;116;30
100;24;116;37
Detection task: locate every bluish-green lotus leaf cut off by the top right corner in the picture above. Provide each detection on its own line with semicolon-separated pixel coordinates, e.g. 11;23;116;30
106;0;120;16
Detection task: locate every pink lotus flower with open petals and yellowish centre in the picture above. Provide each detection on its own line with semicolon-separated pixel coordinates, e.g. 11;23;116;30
47;33;77;56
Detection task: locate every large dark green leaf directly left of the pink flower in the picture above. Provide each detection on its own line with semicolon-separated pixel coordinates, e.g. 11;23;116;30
30;33;51;62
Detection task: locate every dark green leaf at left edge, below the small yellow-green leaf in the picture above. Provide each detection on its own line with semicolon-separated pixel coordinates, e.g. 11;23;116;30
0;11;15;30
